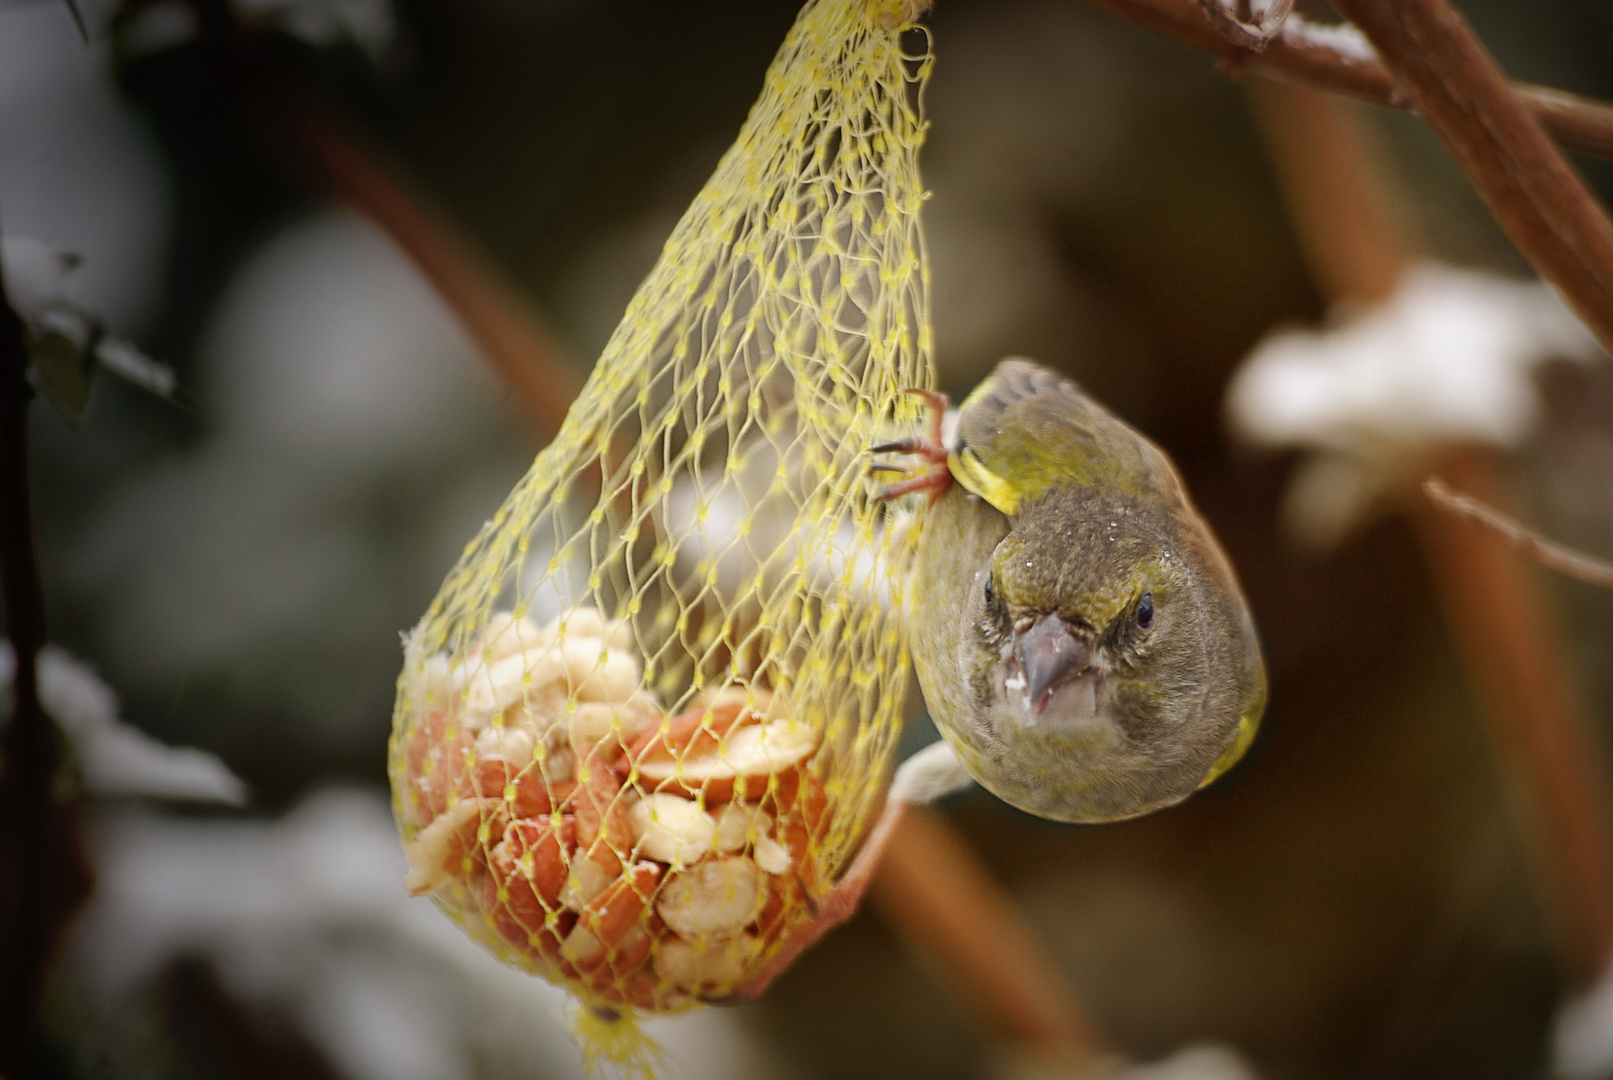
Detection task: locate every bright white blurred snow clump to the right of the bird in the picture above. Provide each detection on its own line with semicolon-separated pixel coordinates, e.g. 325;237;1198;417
1226;264;1602;548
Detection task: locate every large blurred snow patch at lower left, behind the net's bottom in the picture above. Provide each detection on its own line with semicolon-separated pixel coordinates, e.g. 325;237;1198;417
71;788;792;1080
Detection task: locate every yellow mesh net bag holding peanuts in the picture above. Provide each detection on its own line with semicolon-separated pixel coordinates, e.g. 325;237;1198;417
389;0;934;1016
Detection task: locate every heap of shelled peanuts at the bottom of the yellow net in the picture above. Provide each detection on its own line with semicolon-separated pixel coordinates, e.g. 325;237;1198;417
402;608;829;1011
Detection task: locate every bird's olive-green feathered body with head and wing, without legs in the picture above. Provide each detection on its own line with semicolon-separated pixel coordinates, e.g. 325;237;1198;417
913;359;1266;822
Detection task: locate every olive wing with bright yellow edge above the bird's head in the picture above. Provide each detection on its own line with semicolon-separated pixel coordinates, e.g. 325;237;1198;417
947;358;1174;516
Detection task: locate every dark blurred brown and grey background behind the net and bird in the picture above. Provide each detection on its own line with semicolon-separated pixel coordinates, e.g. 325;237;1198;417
9;0;1613;1080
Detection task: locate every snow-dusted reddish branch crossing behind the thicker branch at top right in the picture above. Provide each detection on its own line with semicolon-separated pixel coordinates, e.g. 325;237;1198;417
1087;0;1613;158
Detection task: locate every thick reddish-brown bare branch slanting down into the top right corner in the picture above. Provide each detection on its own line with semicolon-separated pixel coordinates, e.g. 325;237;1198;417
1334;0;1613;364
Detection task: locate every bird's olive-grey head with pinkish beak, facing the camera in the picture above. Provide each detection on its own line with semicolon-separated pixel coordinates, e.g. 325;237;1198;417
969;492;1265;820
